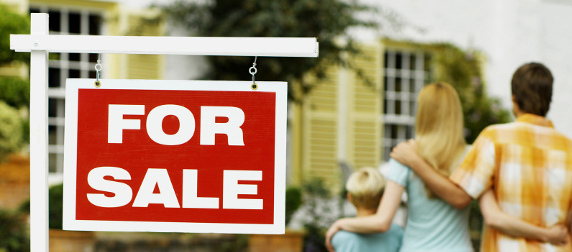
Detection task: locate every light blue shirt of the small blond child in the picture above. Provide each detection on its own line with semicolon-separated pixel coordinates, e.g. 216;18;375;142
332;224;403;252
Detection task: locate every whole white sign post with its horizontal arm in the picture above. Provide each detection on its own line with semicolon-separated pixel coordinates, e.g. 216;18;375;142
10;13;318;252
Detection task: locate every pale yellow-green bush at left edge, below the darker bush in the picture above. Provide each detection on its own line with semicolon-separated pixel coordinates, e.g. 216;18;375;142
0;100;24;161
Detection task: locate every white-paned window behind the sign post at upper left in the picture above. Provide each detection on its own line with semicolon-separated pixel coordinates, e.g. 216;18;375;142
30;5;102;173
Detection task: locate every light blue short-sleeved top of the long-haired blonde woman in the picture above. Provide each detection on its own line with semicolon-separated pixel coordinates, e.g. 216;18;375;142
386;159;473;252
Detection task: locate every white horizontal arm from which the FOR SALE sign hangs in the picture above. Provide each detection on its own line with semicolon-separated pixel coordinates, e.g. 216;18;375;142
10;35;319;57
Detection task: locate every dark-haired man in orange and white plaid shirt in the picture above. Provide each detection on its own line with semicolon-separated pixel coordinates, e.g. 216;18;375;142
391;63;572;251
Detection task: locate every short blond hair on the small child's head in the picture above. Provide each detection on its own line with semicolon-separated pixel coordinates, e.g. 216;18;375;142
346;167;385;210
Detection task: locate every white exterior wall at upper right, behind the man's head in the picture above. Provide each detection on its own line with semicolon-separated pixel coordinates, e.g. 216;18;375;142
357;0;572;138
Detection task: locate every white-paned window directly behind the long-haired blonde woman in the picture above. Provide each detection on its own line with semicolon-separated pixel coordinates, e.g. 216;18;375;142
382;49;430;161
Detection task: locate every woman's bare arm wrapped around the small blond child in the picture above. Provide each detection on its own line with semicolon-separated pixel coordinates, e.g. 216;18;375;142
326;180;404;251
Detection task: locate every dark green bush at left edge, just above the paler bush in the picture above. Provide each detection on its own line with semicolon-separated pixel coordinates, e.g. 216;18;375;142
0;78;30;108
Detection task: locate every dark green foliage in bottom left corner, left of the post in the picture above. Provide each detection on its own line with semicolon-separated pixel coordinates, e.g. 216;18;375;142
0;209;30;252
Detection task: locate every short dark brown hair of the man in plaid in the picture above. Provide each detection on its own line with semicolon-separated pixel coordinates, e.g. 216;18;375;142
511;62;554;116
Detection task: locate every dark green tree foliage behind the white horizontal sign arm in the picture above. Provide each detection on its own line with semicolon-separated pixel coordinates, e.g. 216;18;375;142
161;0;378;101
